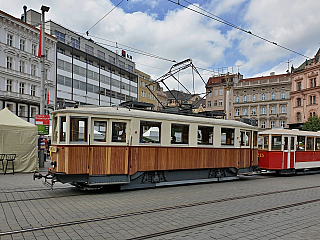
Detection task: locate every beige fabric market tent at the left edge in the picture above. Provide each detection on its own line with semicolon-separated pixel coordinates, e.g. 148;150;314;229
0;108;38;172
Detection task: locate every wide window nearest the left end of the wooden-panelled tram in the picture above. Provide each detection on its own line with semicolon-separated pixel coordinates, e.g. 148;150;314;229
70;117;88;142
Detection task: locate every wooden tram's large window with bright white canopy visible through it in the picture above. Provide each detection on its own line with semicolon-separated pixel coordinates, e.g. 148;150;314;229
140;121;161;143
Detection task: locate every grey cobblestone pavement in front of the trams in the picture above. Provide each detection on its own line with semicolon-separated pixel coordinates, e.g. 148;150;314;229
0;167;320;239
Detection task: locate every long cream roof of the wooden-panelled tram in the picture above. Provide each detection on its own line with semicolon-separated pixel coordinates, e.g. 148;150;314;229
52;106;258;130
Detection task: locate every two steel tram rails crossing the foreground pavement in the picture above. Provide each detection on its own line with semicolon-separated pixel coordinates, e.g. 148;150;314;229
0;185;320;236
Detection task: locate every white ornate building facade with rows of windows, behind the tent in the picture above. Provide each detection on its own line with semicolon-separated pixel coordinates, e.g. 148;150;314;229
0;10;57;123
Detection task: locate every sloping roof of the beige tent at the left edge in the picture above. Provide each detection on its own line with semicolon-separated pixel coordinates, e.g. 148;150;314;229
0;108;38;131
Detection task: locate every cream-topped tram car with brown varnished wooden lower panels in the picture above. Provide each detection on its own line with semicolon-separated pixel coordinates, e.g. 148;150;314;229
48;107;258;189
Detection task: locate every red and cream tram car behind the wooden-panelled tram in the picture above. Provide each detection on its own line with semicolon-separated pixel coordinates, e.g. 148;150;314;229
258;129;320;173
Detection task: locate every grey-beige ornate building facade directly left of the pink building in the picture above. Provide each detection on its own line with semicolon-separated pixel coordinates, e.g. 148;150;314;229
233;73;291;129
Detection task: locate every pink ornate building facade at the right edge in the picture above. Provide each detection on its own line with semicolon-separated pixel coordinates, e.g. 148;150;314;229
291;49;320;127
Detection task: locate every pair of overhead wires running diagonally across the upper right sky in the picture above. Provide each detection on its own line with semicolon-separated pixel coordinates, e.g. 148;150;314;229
168;0;311;59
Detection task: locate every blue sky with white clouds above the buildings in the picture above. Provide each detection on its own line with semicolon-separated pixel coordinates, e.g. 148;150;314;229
0;0;320;93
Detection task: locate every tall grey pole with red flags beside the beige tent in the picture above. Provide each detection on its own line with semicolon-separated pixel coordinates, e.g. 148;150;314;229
39;5;50;168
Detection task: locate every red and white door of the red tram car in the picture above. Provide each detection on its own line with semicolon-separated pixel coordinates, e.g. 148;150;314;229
282;136;296;169
